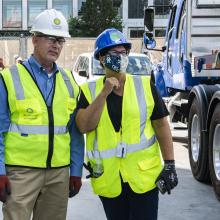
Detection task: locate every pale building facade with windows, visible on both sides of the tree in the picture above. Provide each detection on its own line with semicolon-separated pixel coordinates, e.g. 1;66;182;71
0;0;170;38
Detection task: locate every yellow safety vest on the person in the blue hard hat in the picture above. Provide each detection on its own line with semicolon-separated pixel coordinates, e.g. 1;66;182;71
81;75;162;198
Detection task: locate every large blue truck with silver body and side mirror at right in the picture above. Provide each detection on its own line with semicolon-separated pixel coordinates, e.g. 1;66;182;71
144;0;220;200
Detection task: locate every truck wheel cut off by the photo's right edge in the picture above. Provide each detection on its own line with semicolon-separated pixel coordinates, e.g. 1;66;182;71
209;103;220;201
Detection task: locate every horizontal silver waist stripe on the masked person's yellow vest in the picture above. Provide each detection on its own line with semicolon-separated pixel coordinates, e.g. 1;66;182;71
86;135;156;160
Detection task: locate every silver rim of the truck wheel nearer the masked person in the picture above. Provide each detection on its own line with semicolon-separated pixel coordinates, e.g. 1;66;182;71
191;114;200;162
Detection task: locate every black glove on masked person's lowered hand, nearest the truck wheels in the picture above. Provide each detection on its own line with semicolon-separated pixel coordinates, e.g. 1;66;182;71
155;160;178;194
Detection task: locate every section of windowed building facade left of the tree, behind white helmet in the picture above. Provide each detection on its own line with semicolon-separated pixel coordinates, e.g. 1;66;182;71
0;0;85;36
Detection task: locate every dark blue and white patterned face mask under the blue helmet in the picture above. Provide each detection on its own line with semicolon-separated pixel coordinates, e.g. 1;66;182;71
104;54;128;73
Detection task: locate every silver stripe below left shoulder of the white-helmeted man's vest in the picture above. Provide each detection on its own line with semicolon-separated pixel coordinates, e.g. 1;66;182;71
9;65;24;100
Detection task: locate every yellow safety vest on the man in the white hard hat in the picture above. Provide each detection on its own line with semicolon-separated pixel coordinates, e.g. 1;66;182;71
1;64;79;168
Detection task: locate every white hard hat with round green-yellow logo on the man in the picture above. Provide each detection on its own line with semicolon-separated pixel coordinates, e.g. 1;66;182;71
30;9;70;37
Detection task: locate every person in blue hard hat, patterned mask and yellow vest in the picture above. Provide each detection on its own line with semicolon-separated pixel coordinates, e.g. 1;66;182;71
76;28;178;220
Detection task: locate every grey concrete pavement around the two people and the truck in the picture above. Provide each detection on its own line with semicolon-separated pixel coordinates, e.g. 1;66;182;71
0;130;220;220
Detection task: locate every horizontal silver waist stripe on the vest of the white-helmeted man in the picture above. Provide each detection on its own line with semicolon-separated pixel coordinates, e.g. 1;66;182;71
8;123;68;134
